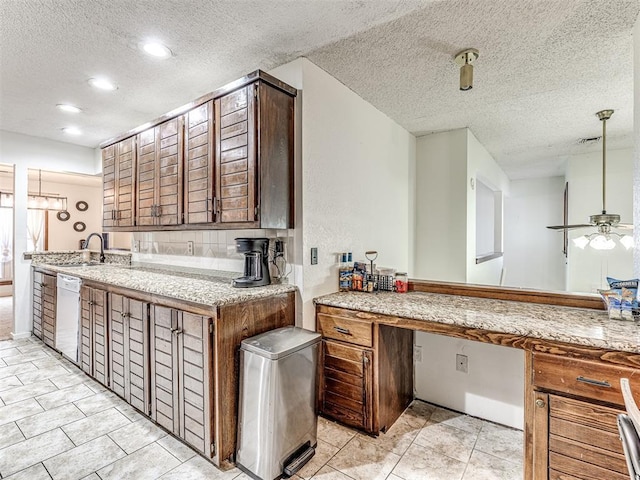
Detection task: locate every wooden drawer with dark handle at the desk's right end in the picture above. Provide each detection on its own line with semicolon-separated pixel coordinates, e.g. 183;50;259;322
533;353;640;406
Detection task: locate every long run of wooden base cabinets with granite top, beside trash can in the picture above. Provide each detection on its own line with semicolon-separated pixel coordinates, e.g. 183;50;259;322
33;257;296;468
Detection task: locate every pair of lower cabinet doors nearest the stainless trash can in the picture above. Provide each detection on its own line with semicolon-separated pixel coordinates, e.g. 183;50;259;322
150;305;214;456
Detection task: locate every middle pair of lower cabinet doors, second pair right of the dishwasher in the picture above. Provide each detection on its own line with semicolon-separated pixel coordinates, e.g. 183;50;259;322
108;294;149;412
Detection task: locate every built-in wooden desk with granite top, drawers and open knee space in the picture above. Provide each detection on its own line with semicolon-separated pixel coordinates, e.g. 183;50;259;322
315;292;640;480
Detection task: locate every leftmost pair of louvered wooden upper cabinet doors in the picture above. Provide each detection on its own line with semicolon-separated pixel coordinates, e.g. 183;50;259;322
102;137;136;227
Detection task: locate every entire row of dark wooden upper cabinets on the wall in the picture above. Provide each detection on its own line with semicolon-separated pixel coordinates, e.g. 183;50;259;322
102;70;296;231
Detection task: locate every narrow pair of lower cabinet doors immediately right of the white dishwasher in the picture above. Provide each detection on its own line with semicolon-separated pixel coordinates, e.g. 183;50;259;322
80;285;109;386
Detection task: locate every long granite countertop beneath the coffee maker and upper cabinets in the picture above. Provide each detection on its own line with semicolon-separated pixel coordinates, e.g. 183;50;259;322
34;263;296;306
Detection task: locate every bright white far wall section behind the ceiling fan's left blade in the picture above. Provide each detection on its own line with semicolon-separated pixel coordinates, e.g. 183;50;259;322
504;177;566;291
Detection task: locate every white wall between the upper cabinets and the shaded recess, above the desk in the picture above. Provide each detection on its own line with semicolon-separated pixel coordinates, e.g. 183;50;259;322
272;59;415;329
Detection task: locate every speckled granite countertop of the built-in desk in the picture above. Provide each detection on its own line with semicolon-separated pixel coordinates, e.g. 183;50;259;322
314;292;640;353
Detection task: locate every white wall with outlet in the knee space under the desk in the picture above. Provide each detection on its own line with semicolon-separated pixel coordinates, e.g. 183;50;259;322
415;332;524;429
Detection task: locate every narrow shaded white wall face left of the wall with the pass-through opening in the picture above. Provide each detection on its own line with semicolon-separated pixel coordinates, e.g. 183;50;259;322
413;129;467;282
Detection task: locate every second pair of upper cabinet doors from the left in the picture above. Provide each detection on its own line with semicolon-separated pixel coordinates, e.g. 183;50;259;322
136;117;184;226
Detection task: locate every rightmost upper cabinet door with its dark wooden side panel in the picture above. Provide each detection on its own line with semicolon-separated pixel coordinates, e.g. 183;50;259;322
215;80;294;228
